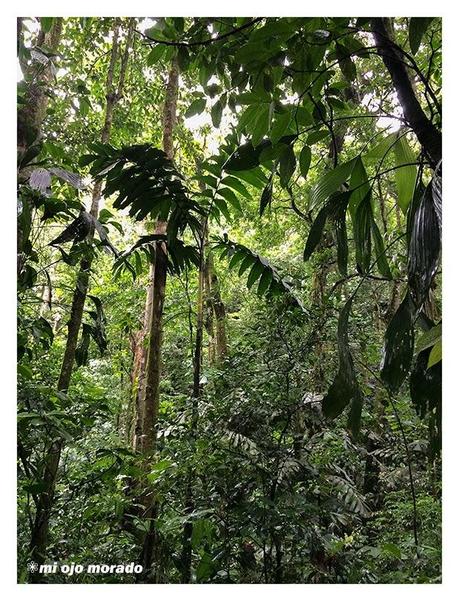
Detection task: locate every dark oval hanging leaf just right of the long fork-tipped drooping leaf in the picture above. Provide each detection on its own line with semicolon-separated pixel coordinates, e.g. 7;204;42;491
381;294;414;392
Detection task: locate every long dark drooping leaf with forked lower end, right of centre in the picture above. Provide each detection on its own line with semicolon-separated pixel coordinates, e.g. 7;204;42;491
322;297;362;434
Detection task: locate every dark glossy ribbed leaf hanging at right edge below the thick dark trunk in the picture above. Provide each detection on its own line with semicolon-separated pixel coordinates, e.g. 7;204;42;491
408;183;441;307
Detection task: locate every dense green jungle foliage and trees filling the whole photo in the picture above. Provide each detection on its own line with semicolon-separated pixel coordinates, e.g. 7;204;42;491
17;17;442;583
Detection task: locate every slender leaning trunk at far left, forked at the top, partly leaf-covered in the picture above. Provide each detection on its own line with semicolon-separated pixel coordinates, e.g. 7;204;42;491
30;20;133;582
